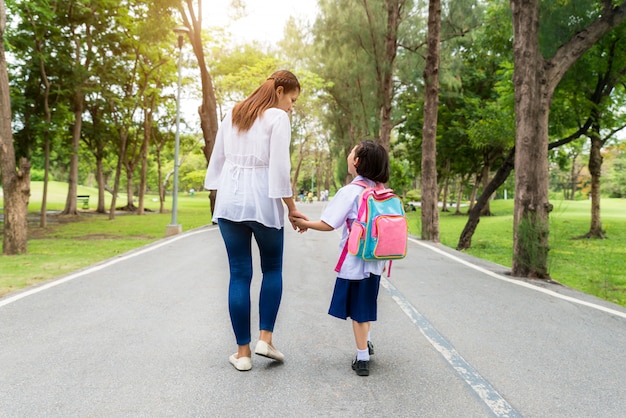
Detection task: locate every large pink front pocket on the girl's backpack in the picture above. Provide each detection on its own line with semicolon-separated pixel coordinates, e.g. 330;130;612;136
373;215;409;259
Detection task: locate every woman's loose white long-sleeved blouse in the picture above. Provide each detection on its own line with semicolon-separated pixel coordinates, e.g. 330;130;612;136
204;108;292;229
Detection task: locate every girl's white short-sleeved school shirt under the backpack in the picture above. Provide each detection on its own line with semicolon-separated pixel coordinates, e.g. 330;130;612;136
320;176;385;280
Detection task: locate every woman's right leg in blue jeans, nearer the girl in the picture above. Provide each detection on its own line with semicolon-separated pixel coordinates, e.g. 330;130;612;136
253;223;284;346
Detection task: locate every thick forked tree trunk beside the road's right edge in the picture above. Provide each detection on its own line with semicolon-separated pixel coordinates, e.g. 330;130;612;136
511;0;626;279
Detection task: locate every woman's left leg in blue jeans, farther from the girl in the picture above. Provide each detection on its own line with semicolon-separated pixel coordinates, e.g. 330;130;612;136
218;219;252;357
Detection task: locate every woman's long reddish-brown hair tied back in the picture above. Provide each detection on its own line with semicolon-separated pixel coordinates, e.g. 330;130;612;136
233;70;300;132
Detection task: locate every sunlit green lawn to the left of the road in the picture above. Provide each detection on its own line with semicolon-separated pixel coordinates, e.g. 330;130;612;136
0;182;211;296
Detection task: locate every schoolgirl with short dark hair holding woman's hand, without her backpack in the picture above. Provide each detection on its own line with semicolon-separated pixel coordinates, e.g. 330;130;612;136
294;140;389;376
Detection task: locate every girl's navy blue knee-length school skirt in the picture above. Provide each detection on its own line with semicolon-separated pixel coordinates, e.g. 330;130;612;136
328;273;380;322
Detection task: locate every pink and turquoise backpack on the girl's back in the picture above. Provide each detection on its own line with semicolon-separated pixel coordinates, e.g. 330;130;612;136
335;180;409;276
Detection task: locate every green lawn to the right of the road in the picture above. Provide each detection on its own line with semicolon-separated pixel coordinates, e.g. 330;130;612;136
409;199;626;306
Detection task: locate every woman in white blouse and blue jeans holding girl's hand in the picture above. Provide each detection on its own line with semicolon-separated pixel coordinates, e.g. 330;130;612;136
204;71;306;371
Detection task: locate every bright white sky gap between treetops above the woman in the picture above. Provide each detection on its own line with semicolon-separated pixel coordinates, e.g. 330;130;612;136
202;0;317;45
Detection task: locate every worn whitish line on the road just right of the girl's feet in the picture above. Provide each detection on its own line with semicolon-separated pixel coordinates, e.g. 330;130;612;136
380;277;521;418
